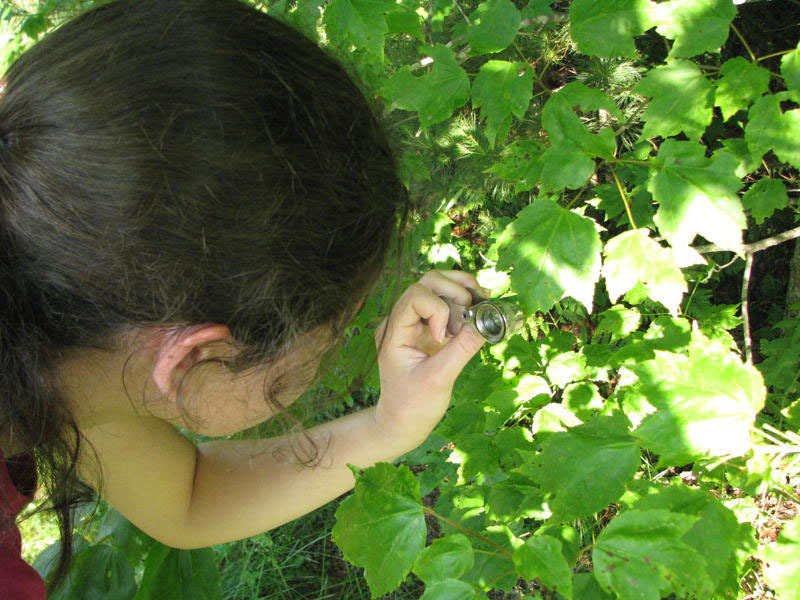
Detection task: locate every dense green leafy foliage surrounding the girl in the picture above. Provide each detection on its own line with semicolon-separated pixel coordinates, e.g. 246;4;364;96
0;0;800;600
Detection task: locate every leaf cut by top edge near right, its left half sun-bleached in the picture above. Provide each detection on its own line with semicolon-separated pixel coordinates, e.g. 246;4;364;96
653;0;736;58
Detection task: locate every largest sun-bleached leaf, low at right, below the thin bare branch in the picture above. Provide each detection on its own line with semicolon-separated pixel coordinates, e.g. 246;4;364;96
630;343;766;465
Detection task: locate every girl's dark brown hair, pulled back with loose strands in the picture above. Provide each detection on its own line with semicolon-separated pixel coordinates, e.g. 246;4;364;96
0;0;410;592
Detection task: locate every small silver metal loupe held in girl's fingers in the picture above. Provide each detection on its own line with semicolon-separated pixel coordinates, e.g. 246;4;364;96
440;290;525;344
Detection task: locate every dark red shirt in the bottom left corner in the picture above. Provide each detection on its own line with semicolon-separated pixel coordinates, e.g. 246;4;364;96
0;452;46;600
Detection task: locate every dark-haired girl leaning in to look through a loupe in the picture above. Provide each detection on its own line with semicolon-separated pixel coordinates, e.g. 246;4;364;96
0;0;483;600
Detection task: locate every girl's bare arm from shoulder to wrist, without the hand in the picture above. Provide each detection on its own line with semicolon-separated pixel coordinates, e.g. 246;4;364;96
79;407;410;548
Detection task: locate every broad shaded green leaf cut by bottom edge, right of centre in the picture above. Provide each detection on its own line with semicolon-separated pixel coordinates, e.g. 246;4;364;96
592;510;713;600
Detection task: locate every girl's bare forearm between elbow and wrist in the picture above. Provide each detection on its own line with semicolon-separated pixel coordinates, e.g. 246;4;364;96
179;408;411;548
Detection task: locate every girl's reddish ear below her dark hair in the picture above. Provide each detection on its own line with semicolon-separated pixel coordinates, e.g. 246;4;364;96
153;323;231;401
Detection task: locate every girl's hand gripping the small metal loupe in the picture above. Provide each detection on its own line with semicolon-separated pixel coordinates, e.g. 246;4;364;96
375;270;485;453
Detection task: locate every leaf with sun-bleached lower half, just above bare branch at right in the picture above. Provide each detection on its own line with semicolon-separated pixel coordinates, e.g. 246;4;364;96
647;140;747;252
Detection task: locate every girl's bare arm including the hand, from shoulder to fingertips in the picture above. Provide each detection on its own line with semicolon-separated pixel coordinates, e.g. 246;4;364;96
81;271;483;548
